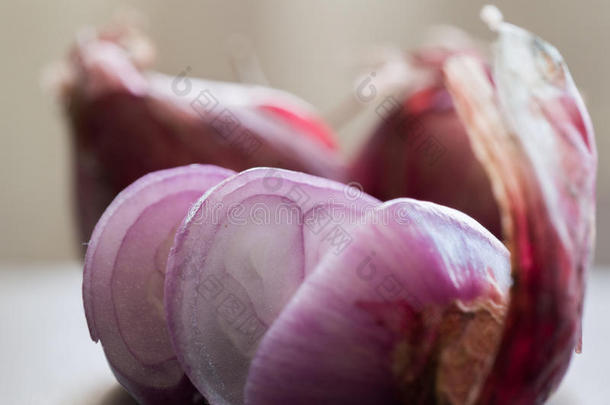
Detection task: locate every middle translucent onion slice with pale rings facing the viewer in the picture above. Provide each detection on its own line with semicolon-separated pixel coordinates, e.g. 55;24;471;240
165;168;378;405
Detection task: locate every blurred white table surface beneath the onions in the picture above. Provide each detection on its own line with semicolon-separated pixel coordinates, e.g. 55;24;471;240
0;264;610;405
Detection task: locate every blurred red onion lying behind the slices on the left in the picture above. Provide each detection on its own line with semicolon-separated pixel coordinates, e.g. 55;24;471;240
57;27;344;246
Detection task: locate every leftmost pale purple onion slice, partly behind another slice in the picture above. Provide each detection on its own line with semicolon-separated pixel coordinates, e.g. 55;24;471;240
83;165;234;404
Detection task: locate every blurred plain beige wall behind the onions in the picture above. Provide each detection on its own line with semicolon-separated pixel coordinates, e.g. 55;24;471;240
0;0;610;264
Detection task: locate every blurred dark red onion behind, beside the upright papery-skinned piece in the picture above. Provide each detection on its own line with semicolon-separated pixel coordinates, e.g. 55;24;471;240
350;35;502;238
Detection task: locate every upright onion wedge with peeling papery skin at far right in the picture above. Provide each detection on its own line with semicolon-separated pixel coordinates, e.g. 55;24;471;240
446;9;597;405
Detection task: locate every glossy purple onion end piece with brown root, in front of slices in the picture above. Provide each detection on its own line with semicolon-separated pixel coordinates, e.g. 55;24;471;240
246;199;510;405
